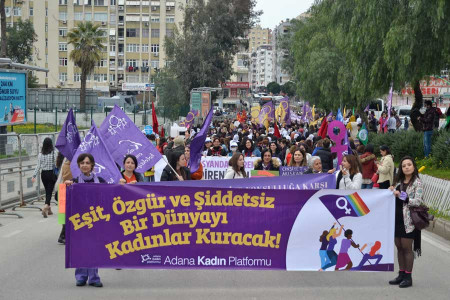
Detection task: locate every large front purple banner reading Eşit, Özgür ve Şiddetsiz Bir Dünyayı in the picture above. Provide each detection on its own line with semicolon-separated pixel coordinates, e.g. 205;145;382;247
66;184;395;271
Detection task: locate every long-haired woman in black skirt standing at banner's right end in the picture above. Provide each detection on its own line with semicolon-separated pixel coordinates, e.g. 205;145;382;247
389;156;423;288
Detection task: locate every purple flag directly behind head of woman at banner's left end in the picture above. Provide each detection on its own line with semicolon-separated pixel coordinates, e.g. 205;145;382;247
70;122;122;184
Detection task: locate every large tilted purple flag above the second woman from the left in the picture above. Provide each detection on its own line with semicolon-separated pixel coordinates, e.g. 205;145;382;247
99;105;162;173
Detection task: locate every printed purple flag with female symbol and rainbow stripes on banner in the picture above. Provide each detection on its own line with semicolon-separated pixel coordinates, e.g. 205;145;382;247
319;192;370;220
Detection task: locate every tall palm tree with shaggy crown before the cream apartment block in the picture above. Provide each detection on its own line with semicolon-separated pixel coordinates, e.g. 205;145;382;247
67;22;104;111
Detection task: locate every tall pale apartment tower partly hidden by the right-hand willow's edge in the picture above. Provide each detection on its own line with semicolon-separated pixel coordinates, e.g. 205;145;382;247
272;19;291;85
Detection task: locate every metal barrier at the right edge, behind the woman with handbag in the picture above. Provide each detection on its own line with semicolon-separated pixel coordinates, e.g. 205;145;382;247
420;175;450;216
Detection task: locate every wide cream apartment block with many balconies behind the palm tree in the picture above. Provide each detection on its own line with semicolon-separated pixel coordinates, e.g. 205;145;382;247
1;0;188;93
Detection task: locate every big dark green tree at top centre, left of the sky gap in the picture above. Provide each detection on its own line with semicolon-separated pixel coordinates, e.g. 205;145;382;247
164;0;259;110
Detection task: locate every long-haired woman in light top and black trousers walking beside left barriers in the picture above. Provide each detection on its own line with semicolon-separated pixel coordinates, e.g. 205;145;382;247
31;138;56;218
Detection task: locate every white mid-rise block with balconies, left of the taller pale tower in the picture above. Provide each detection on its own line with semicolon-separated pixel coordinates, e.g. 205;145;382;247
250;45;274;91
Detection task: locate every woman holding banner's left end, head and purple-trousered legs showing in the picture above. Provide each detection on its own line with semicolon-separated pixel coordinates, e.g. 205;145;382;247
65;153;106;287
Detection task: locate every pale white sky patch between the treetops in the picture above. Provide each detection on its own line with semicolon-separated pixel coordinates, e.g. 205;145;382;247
256;0;314;29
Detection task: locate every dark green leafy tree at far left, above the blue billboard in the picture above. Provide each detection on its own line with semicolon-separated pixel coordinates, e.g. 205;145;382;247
6;19;37;64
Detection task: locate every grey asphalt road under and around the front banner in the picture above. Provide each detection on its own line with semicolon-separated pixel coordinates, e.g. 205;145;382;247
0;209;450;300
